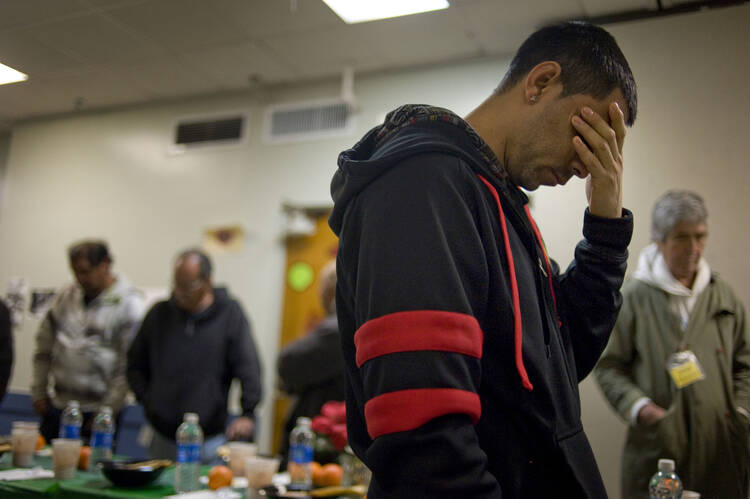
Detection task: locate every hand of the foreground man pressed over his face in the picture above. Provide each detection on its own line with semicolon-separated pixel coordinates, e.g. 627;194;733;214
572;102;625;218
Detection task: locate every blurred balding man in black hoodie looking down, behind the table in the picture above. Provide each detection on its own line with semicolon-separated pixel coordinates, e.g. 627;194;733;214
127;250;261;461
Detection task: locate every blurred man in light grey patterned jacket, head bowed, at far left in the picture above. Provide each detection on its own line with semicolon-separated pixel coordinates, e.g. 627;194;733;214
31;240;144;442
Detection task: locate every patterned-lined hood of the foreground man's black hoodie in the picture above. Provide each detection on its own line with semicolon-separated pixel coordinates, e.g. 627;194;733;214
328;104;507;235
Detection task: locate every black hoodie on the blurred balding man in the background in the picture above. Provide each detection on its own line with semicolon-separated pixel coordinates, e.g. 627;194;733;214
127;288;261;440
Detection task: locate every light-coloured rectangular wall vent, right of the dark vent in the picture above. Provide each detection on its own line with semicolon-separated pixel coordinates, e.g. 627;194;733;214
263;99;354;143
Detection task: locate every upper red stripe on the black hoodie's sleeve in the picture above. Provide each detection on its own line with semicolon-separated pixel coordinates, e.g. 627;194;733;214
354;310;484;367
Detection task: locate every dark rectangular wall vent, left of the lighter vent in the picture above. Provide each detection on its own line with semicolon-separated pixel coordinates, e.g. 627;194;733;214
172;114;246;152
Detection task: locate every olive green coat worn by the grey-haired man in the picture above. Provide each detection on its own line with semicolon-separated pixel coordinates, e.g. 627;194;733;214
594;274;750;499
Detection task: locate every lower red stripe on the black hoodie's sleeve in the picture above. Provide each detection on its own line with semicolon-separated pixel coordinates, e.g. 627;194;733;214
365;388;482;439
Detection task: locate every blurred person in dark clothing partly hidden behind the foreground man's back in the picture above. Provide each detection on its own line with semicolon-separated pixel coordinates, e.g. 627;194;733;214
278;260;344;466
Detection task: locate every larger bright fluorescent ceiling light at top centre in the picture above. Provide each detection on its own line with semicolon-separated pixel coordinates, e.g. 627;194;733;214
323;0;448;24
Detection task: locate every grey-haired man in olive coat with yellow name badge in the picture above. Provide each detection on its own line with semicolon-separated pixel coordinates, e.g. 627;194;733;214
595;191;750;499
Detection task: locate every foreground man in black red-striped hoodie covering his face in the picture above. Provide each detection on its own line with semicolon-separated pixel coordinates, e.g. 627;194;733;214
329;23;637;499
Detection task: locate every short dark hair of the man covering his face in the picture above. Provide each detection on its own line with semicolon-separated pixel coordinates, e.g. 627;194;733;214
497;21;638;126
